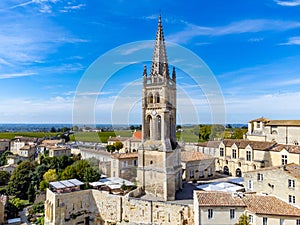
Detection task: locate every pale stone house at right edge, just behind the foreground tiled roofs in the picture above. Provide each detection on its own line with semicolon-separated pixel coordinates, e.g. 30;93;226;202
244;163;300;208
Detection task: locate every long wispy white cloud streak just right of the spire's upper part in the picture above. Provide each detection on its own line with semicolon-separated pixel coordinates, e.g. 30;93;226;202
167;19;300;43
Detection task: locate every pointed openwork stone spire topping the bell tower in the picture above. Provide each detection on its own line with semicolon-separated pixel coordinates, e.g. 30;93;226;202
150;15;169;77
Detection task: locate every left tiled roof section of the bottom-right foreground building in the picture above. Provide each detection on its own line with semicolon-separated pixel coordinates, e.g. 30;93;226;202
196;191;246;207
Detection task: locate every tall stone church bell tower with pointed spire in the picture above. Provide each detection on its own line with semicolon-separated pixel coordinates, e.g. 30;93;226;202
137;17;181;201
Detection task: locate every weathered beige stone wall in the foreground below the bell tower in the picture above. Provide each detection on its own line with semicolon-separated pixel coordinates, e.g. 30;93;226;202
45;189;194;225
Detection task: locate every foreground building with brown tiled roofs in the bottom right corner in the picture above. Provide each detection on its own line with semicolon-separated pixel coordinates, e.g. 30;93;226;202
194;191;300;225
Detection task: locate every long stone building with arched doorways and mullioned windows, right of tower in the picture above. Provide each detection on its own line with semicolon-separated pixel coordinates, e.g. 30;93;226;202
197;139;300;177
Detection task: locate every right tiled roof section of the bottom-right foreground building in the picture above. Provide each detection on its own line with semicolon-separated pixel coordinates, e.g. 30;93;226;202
242;194;300;217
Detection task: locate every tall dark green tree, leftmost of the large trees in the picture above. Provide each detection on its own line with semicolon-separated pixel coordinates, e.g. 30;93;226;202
7;161;34;199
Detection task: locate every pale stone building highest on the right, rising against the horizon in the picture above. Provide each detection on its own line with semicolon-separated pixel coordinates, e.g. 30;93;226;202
245;117;300;145
